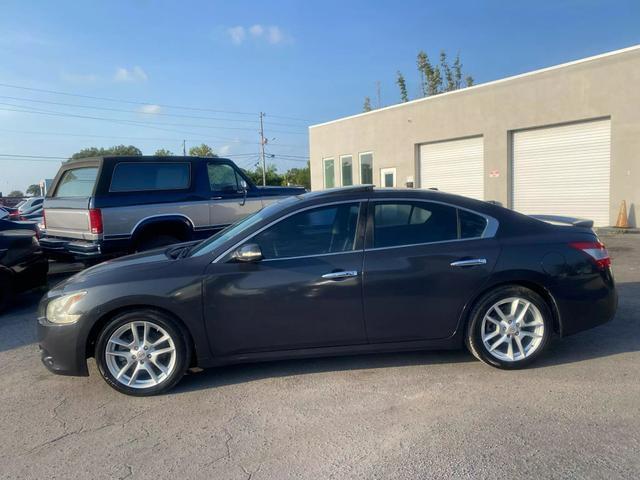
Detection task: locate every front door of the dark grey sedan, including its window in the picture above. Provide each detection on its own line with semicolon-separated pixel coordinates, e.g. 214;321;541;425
204;202;366;355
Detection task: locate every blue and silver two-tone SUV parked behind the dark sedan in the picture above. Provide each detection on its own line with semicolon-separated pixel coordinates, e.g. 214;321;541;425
41;157;305;260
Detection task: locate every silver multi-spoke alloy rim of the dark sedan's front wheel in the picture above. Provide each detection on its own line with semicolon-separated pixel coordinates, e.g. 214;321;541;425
105;321;176;389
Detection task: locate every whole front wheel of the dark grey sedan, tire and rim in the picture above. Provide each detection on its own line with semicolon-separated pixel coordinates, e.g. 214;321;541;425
95;310;190;396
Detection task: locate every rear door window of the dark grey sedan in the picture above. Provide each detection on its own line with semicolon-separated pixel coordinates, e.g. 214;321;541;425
373;201;458;248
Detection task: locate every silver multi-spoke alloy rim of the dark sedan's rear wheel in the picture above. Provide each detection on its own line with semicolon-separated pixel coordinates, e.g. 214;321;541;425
481;297;544;362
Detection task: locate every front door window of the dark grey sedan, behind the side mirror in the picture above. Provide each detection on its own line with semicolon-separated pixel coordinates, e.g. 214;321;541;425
249;203;360;259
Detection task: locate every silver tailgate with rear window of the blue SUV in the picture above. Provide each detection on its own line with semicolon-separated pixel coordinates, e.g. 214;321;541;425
44;159;101;240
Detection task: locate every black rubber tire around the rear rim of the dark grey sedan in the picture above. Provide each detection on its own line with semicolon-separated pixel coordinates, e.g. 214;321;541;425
465;285;553;370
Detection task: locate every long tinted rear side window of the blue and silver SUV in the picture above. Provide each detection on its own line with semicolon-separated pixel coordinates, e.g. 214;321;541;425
109;162;191;192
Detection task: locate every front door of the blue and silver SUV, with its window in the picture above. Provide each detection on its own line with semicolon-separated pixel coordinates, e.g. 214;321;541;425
207;162;262;228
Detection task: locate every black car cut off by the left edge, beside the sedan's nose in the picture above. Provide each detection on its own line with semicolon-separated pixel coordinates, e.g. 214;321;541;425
0;216;49;312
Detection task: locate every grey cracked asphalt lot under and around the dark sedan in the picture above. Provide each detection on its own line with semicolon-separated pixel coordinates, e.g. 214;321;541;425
0;235;640;480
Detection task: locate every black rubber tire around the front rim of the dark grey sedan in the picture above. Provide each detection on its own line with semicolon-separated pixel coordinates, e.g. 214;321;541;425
95;309;191;397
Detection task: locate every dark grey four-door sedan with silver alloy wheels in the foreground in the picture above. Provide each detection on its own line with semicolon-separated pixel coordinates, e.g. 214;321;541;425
38;186;617;396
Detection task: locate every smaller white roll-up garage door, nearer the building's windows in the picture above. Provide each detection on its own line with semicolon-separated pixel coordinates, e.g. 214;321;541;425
420;137;484;200
